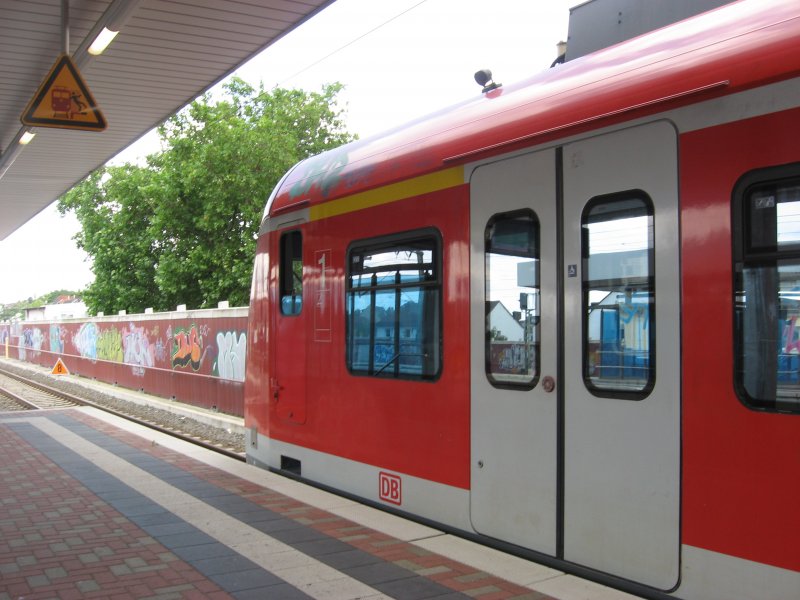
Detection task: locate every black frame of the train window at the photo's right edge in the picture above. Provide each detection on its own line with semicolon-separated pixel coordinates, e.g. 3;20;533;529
731;163;800;414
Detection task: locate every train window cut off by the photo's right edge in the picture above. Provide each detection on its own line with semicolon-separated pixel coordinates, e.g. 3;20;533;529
733;166;800;413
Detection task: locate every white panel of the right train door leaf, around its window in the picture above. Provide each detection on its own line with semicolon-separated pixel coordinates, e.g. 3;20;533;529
564;122;680;589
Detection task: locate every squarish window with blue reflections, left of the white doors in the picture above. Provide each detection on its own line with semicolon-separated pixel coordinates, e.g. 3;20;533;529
346;232;442;379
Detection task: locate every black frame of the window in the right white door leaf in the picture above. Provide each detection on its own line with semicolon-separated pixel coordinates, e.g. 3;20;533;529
581;189;658;401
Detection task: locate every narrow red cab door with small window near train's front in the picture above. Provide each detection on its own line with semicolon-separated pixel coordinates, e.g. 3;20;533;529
270;229;309;423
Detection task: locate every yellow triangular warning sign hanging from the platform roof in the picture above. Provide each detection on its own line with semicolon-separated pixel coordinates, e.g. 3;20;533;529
20;54;106;131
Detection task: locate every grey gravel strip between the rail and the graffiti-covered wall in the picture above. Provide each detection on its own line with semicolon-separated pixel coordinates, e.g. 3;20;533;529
2;362;245;454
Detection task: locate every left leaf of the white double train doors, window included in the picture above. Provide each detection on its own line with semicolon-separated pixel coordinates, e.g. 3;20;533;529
470;150;558;554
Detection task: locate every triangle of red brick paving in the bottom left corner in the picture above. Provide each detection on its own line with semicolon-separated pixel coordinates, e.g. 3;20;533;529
0;418;231;600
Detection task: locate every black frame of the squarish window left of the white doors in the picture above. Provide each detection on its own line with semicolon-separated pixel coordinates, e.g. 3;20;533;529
344;228;444;382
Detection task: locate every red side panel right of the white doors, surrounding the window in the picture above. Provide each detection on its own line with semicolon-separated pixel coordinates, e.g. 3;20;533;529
681;109;800;571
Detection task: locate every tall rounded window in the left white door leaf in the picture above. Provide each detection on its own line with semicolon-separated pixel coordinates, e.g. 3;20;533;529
484;210;540;389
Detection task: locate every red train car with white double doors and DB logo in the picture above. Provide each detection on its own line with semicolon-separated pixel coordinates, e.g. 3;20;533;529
245;0;800;600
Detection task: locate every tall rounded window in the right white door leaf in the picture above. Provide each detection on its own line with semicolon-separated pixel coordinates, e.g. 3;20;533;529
581;191;655;400
